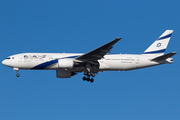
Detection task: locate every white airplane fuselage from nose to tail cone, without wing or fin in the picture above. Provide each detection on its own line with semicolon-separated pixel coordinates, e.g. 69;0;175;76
3;53;172;72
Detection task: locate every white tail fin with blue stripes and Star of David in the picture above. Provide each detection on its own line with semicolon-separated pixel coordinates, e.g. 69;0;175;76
143;30;173;56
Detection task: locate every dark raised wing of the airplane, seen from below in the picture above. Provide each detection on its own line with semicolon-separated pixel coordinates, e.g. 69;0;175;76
75;38;121;61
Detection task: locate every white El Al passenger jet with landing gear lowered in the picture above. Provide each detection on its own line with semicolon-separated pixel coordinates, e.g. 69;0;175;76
2;30;177;83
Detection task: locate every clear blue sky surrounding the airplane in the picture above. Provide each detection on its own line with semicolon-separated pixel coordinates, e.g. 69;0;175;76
0;0;180;120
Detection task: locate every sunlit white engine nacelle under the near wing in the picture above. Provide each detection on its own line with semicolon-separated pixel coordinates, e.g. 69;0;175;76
58;59;74;68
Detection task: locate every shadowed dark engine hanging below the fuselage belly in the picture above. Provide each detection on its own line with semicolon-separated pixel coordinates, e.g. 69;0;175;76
56;70;77;78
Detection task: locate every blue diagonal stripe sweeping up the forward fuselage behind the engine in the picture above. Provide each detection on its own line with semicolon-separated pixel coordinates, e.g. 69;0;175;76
32;55;79;69
